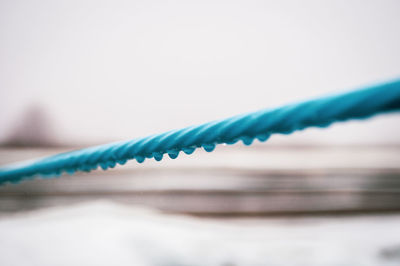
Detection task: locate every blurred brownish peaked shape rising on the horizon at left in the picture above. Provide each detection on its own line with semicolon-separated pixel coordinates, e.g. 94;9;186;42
2;105;56;147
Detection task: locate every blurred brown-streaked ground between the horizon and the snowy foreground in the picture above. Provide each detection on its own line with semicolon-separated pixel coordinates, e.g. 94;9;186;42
0;145;400;216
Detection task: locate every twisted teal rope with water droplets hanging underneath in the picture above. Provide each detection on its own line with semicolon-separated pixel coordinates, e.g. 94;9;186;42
0;80;400;184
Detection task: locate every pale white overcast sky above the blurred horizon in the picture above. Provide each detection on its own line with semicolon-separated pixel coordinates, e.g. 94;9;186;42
0;0;400;144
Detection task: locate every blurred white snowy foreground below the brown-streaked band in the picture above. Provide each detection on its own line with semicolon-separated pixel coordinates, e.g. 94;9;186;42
0;201;400;266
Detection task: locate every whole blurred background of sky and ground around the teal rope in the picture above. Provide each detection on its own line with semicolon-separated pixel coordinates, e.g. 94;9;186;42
0;0;400;266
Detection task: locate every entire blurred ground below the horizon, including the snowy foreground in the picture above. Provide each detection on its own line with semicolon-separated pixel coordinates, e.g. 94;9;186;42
0;145;400;266
